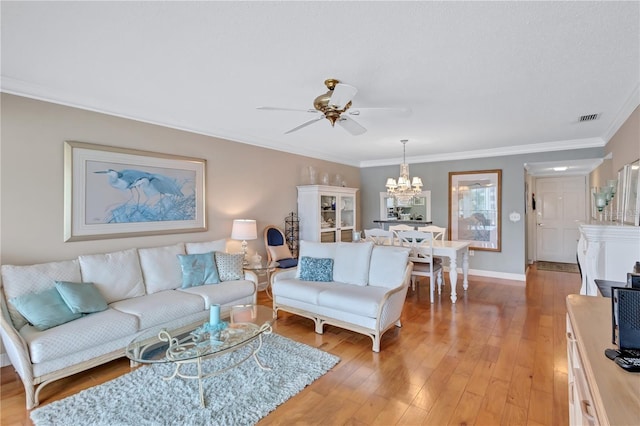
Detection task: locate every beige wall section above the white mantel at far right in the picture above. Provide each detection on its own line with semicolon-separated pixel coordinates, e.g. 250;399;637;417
589;107;640;187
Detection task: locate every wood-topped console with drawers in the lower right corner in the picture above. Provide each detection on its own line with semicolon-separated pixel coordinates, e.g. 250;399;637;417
567;294;640;425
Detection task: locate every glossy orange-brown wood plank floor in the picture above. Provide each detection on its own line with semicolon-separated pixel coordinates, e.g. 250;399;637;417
0;266;580;425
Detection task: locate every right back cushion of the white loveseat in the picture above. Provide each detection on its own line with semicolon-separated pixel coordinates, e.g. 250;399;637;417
369;246;409;288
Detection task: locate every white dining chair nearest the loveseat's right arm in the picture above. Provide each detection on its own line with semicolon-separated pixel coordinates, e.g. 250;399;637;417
396;231;442;303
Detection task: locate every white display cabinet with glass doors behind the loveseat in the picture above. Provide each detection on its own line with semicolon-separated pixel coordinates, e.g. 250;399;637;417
298;185;358;243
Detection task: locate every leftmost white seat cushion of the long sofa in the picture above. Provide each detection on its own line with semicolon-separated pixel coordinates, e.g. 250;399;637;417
20;309;138;364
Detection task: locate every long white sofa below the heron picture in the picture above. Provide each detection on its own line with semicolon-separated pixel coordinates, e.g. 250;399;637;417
0;240;257;409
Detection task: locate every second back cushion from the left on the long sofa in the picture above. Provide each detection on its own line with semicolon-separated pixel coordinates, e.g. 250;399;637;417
78;249;145;303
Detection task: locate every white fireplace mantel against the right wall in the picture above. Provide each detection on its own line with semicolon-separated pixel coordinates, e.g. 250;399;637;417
578;222;640;296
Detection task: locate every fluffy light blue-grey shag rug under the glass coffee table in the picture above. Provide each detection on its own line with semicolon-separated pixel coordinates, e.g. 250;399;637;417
31;334;340;426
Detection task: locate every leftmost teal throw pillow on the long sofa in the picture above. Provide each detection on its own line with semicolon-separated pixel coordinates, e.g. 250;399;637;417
9;287;82;331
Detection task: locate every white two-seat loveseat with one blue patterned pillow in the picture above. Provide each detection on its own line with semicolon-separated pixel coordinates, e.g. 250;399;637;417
272;241;413;352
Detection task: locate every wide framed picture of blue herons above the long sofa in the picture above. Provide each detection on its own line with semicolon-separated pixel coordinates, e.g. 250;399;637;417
64;141;207;241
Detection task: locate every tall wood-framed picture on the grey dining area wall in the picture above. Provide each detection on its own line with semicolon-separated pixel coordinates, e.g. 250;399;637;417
449;170;502;251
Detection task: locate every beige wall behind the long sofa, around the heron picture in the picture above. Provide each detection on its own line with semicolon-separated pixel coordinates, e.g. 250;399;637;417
0;94;360;264
